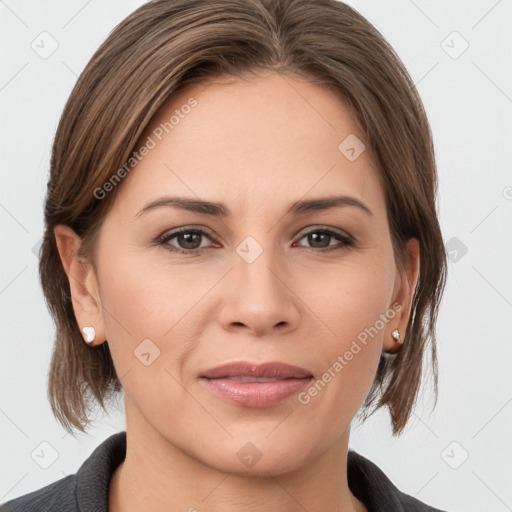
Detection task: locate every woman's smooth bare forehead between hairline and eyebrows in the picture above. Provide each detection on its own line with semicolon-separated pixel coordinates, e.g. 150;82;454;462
110;69;383;218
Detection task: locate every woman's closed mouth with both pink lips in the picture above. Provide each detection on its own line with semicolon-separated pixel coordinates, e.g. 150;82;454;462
199;361;313;408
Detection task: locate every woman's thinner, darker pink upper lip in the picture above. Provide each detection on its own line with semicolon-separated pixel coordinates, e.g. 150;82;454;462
200;361;313;379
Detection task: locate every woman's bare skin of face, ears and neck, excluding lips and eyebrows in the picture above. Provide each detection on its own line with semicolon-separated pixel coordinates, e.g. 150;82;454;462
55;72;419;512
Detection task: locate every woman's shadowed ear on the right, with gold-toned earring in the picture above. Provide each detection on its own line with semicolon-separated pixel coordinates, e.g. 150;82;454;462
383;238;420;354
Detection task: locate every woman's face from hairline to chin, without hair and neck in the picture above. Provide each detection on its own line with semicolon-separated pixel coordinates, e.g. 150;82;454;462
67;73;416;474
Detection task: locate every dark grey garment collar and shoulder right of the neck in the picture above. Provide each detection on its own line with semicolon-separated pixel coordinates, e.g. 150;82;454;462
347;450;443;512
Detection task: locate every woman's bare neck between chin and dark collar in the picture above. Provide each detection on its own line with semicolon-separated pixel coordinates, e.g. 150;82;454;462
108;406;366;512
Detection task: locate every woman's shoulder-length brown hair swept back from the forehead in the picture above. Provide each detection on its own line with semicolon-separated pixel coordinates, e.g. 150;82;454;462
39;0;446;434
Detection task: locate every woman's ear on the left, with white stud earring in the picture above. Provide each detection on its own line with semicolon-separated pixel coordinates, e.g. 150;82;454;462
53;224;106;346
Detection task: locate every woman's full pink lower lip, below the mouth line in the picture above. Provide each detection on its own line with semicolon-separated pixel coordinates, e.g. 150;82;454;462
200;377;312;408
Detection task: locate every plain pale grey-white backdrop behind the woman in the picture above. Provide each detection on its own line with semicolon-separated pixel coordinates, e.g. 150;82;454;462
0;0;512;512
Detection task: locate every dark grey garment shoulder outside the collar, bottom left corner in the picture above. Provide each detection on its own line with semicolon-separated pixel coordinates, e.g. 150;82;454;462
0;475;78;512
